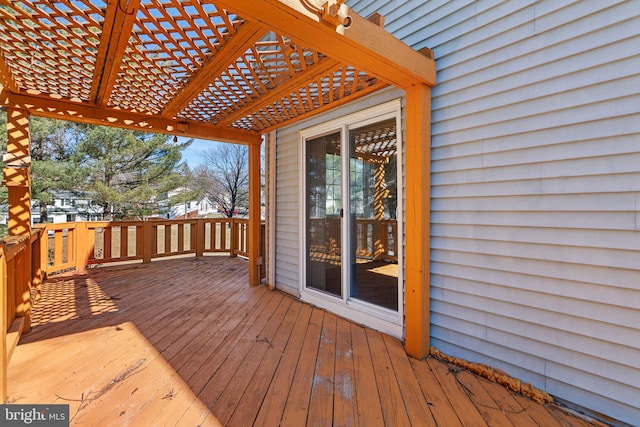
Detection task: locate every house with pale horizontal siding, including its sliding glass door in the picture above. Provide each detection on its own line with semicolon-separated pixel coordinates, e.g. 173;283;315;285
267;0;640;424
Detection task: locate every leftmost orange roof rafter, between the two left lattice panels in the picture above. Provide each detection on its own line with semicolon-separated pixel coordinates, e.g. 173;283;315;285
89;0;140;107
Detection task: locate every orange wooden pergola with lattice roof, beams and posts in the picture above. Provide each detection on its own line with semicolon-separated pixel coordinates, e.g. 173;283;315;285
0;0;435;357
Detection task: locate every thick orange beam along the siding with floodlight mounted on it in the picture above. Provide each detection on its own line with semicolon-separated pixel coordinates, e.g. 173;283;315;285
216;0;436;89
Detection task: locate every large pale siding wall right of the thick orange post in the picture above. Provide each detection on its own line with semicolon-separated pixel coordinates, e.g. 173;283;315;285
347;0;640;425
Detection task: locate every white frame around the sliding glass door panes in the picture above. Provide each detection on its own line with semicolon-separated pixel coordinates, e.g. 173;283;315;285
298;99;404;339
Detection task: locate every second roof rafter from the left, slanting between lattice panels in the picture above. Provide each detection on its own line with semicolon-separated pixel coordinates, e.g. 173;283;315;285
161;22;267;118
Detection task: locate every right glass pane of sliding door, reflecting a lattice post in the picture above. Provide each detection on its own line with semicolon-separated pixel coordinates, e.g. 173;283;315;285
348;118;398;311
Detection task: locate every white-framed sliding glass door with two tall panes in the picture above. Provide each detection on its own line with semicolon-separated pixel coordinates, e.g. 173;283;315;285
301;102;402;327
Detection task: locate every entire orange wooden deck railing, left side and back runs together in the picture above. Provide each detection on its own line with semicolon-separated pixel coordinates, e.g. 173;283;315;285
0;218;264;402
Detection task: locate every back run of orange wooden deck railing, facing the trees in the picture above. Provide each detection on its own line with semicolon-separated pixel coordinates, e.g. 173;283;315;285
41;218;254;274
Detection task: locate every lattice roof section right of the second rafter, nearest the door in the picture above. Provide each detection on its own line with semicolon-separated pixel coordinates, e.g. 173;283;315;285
179;33;379;131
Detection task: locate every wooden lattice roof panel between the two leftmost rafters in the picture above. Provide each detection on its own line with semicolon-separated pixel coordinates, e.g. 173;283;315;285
109;0;244;114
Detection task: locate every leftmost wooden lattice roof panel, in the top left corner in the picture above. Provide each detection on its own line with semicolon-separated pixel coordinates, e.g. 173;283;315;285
0;0;106;101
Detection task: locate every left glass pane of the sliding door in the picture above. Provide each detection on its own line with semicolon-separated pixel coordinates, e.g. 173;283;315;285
305;132;343;297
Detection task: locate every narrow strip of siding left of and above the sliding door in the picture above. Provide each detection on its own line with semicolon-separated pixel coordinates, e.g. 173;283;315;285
275;88;404;296
